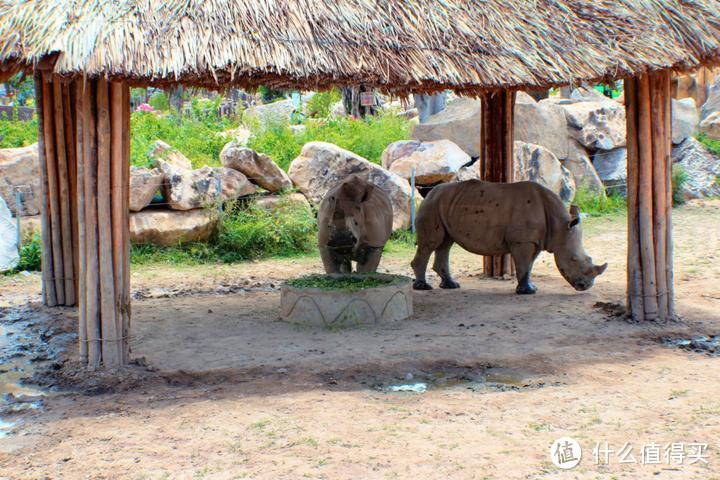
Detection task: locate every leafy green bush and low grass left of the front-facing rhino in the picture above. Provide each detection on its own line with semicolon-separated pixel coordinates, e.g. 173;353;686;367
131;195;316;264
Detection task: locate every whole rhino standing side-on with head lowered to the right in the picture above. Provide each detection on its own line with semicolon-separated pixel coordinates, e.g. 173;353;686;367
412;180;607;294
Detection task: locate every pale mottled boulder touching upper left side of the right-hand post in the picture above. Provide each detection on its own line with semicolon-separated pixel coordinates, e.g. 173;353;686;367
557;98;626;150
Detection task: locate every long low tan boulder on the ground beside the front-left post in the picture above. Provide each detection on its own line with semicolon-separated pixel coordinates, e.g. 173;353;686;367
130;209;218;246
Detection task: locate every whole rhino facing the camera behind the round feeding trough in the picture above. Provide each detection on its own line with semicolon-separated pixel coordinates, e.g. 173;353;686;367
318;175;393;273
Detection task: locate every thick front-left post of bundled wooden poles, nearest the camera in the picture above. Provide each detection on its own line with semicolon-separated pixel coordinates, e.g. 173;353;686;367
77;79;130;368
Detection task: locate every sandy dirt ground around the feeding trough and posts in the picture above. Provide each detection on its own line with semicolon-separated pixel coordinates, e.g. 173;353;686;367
0;202;720;479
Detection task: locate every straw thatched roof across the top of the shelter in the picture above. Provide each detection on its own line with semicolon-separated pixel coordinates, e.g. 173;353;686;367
0;0;720;93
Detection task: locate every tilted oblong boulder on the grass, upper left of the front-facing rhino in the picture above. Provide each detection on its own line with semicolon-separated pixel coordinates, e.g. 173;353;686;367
220;141;292;192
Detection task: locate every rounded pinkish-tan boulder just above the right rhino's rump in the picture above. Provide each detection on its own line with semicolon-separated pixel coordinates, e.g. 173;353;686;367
382;140;470;185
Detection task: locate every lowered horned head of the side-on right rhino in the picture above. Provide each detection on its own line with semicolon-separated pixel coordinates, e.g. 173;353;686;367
554;205;607;291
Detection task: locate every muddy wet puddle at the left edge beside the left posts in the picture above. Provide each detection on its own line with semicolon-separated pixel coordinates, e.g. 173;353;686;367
0;307;70;438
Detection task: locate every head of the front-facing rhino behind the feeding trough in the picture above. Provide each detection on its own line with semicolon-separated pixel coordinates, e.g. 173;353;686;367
328;177;374;253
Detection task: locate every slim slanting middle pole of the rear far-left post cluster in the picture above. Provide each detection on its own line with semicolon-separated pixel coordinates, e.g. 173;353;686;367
52;79;75;305
